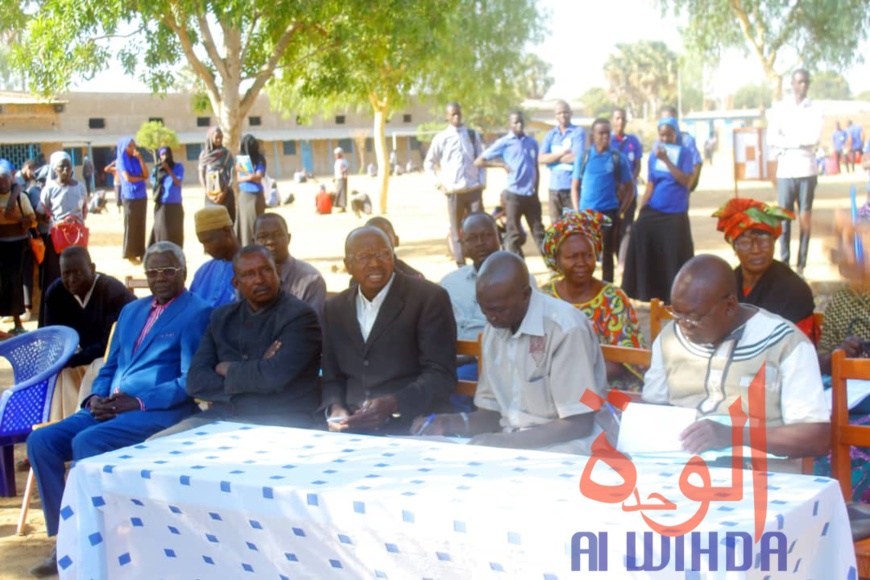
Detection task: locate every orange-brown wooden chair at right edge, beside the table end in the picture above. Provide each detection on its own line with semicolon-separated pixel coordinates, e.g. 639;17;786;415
831;349;870;578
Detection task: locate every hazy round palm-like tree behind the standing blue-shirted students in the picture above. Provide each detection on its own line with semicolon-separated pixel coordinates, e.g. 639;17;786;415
604;40;678;117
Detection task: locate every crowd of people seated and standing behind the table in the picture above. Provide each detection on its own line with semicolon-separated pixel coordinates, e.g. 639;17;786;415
0;71;870;575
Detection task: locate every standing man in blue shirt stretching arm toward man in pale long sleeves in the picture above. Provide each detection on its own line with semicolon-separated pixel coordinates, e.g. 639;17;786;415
474;111;544;256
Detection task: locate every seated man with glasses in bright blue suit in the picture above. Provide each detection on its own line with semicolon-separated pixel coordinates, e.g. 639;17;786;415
27;242;211;576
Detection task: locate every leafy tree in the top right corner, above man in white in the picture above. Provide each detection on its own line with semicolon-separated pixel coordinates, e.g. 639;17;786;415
658;0;870;99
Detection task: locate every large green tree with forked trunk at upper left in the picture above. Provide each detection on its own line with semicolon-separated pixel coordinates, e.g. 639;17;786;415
6;0;350;149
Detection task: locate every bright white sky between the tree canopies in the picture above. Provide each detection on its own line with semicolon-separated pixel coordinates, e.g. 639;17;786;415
74;0;870;98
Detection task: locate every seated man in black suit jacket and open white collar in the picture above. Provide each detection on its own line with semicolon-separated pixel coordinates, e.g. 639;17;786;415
323;226;456;433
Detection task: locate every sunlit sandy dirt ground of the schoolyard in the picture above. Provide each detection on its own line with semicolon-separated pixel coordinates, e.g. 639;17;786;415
0;150;867;579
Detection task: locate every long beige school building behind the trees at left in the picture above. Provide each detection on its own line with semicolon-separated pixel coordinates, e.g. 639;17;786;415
0;92;436;187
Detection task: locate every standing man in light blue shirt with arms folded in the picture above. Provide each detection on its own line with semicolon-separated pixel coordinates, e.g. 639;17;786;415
538;101;586;224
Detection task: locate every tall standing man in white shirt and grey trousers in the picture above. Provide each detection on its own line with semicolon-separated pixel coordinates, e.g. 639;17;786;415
767;69;822;276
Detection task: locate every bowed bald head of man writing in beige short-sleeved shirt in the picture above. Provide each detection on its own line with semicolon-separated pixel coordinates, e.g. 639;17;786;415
476;252;532;332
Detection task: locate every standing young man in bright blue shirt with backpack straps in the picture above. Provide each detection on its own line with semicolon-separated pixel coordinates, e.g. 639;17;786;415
571;118;634;282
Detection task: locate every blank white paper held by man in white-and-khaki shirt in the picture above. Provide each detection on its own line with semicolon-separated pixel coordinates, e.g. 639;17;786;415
616;403;697;453
